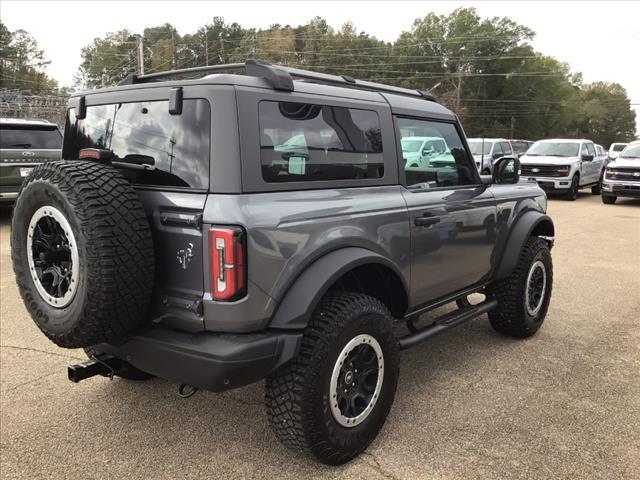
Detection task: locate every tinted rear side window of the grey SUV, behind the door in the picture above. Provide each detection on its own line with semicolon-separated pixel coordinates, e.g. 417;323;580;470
258;101;384;182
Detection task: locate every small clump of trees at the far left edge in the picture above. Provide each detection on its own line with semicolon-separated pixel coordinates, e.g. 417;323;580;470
0;22;58;94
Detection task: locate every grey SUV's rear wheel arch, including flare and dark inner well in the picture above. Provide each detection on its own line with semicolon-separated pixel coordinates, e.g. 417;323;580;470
269;247;409;329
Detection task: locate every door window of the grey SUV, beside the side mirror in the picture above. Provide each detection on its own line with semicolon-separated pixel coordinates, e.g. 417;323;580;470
395;117;475;189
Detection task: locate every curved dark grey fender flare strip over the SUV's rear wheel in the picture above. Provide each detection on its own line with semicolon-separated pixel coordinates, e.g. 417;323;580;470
269;247;409;329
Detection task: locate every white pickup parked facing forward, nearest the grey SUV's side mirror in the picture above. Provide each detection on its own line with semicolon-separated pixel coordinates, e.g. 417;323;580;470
520;139;605;200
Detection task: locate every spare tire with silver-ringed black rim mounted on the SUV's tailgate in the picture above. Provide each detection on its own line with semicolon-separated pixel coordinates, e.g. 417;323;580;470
11;161;154;348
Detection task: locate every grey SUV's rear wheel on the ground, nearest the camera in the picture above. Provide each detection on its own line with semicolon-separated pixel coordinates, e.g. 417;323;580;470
265;292;400;465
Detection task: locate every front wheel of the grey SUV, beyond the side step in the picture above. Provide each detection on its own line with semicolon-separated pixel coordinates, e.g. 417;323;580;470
487;237;553;338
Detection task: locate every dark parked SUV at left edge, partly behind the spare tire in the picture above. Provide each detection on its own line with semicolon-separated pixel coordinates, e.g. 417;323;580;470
0;118;62;202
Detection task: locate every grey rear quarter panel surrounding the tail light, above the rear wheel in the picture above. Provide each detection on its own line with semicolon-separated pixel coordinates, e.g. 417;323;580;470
204;185;410;331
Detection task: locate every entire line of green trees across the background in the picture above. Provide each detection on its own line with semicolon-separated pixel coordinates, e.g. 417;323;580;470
7;8;636;143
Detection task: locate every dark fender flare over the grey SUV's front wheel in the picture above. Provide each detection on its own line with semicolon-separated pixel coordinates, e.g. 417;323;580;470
493;211;555;280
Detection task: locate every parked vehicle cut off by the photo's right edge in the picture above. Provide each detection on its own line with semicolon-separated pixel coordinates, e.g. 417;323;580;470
602;142;640;204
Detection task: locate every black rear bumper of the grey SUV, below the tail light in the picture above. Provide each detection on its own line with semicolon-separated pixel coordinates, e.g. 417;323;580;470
96;327;302;392
